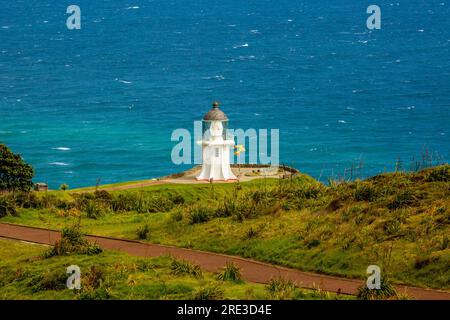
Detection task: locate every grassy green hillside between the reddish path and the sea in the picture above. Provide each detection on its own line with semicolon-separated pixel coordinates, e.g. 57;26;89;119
0;165;450;289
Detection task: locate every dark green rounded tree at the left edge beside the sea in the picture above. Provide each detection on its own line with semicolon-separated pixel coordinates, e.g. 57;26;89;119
0;144;34;191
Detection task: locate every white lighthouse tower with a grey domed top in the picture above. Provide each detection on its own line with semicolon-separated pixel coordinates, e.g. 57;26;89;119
197;102;237;182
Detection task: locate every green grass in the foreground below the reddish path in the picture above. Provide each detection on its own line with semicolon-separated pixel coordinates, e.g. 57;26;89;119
0;239;352;300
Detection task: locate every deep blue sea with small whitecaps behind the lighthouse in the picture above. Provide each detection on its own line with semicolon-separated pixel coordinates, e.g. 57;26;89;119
0;0;450;188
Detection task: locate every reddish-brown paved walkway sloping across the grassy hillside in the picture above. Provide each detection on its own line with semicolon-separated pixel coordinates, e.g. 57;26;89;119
0;223;450;300
